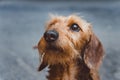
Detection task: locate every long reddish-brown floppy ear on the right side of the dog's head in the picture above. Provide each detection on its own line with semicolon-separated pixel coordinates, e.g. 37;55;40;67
84;33;104;69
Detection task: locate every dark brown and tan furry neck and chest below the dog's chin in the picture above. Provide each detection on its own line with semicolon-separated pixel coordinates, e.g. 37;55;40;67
47;59;99;80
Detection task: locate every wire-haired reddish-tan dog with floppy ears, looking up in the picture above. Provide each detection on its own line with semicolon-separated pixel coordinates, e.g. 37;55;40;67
35;15;104;80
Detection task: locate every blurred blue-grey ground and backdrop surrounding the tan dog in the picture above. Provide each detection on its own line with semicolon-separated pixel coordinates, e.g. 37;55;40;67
0;0;120;80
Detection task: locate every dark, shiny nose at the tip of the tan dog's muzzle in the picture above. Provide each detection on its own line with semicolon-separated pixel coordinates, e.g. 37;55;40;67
44;30;59;42
